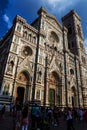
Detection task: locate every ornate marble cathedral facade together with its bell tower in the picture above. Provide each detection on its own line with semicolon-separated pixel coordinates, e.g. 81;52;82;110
0;8;87;107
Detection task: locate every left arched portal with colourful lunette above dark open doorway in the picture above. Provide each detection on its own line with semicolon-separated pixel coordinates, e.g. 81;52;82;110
16;71;31;102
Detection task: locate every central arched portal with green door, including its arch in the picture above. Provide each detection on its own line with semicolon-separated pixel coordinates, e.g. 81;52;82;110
49;71;62;106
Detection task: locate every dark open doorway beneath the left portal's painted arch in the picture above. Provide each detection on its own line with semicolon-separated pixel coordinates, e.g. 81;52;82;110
17;87;25;103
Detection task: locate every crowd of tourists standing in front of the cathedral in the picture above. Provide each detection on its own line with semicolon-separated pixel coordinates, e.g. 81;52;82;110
0;100;87;130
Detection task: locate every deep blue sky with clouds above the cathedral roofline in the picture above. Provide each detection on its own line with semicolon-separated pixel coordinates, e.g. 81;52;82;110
0;0;87;50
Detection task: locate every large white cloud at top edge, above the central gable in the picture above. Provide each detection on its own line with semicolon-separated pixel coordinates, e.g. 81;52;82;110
42;0;80;12
